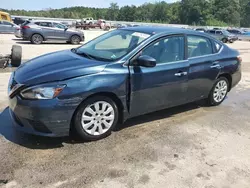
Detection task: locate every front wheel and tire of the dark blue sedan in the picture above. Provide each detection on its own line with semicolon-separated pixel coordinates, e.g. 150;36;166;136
74;96;119;141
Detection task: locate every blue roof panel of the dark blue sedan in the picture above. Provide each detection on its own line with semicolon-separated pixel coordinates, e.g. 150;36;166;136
120;26;210;36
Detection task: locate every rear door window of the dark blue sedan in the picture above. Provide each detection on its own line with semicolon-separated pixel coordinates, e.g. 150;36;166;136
188;36;213;57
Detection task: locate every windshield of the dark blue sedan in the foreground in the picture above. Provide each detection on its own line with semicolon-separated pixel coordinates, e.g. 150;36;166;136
75;29;150;61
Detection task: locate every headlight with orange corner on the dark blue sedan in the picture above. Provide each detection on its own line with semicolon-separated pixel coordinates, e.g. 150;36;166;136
21;85;65;99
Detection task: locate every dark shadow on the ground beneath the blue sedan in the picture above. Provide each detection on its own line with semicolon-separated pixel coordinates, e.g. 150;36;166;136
0;101;205;149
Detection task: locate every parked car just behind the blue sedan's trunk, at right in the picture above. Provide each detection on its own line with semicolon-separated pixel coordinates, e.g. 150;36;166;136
207;30;238;43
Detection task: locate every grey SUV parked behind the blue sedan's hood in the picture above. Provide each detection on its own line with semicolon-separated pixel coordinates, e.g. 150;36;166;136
21;20;84;44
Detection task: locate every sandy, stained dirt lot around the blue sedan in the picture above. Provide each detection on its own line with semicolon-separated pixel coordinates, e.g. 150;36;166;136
0;31;250;188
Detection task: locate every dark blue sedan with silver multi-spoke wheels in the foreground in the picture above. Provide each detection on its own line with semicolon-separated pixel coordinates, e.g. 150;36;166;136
9;27;241;140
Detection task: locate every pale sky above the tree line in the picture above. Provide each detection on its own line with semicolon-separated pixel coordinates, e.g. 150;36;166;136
0;0;176;10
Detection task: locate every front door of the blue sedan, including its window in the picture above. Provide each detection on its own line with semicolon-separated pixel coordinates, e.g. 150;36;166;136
129;35;189;116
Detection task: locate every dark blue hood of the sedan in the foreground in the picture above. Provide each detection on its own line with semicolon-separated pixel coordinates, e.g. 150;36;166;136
14;50;107;85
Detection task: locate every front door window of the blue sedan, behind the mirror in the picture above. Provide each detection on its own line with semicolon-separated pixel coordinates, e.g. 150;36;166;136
142;36;185;64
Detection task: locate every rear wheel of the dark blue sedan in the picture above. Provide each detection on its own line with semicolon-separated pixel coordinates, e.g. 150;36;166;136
208;77;229;106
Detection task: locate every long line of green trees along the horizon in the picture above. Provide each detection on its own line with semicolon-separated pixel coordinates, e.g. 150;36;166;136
3;0;250;27
